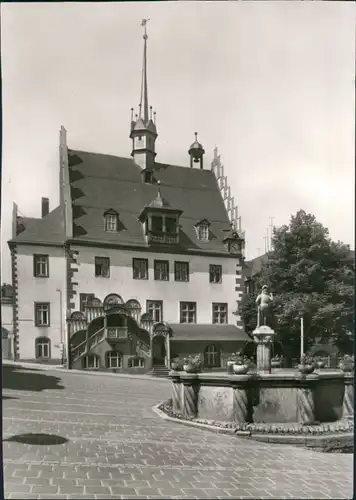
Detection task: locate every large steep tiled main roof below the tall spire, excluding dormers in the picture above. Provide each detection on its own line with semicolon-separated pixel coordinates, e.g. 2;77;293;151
69;150;230;250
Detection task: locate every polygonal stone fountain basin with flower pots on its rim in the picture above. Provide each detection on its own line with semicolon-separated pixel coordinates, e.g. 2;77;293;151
170;370;353;425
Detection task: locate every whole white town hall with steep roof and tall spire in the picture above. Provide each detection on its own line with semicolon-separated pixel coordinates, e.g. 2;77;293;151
9;23;251;372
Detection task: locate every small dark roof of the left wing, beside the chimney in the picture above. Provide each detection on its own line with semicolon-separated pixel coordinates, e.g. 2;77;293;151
10;207;65;245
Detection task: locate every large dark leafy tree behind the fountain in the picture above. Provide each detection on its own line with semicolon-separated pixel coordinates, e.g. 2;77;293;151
240;210;355;357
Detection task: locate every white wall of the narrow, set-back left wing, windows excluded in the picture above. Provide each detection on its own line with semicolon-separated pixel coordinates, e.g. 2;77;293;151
17;245;66;360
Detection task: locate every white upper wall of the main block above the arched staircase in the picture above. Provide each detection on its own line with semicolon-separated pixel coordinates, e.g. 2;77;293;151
71;246;238;324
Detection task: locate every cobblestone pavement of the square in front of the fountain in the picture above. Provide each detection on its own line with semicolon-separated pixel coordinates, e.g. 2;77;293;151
3;366;353;499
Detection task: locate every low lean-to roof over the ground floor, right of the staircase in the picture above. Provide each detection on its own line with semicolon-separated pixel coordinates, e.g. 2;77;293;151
169;323;251;342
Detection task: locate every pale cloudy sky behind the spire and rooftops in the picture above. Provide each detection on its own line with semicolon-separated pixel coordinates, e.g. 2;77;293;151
1;0;356;282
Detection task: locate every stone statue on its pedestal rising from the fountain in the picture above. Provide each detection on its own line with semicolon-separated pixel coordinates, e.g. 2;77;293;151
253;285;276;373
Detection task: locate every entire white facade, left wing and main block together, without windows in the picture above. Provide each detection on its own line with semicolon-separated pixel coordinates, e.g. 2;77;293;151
17;241;240;360
